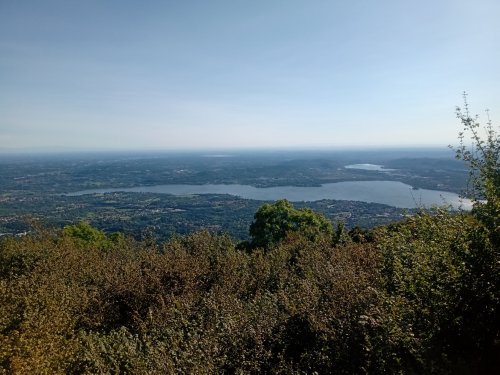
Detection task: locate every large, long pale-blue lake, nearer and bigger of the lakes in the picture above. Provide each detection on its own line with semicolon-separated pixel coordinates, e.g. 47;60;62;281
66;181;472;210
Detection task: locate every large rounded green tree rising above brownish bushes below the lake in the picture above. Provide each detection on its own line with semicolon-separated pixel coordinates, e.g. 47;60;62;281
250;199;333;248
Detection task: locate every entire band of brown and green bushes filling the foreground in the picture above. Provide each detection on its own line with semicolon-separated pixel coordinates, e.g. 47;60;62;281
0;212;498;373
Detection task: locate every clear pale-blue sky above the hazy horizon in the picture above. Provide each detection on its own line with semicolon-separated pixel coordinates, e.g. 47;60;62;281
0;0;500;152
